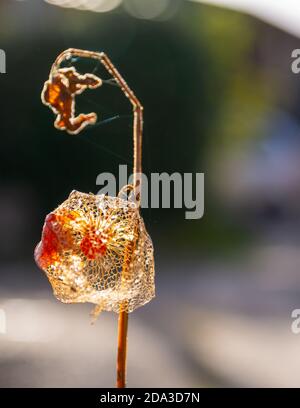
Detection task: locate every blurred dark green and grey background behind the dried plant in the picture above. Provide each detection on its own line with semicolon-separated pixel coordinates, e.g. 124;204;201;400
0;0;300;387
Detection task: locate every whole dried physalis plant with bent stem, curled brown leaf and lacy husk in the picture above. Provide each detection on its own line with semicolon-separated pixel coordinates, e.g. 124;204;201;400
35;48;155;388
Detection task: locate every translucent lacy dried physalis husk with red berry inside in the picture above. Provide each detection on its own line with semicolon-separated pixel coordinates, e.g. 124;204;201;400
35;191;155;313
